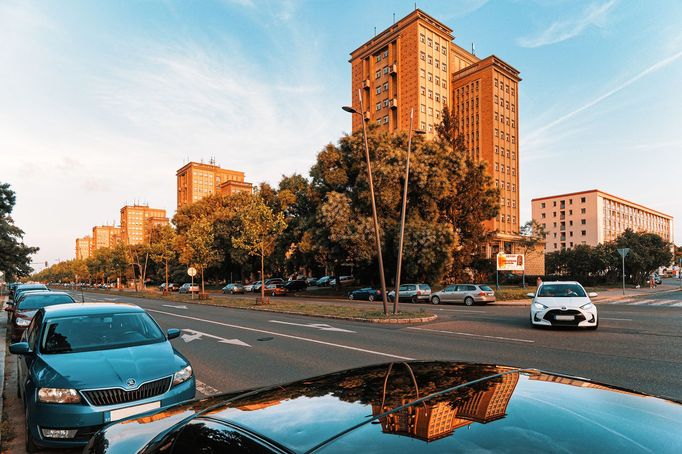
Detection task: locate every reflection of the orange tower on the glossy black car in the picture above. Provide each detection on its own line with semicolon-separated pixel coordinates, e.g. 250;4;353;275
372;373;519;441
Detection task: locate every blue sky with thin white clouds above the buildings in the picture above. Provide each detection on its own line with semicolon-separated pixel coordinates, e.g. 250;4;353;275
0;0;682;269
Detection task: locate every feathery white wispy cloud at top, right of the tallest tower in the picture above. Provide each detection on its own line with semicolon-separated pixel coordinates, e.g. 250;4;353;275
518;0;616;47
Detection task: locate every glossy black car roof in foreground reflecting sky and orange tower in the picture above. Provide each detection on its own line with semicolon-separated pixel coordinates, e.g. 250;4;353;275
85;362;682;454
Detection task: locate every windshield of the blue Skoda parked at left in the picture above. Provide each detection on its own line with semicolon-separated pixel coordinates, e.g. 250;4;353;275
41;312;166;354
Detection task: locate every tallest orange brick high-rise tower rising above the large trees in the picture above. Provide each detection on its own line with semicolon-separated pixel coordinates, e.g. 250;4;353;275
350;9;524;258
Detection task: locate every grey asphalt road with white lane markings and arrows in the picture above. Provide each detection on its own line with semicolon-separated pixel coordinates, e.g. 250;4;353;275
67;292;682;401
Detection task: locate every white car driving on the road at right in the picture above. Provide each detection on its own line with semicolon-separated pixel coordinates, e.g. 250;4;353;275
528;282;599;329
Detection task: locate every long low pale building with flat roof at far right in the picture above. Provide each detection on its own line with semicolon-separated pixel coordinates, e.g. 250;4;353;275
531;189;674;252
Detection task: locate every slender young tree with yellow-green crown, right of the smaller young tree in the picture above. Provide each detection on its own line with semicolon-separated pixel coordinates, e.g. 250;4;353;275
232;194;286;303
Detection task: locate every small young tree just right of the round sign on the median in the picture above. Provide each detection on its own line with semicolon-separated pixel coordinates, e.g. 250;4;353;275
178;217;222;295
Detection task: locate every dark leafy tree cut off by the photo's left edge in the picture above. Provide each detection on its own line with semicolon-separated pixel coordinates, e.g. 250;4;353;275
0;183;38;281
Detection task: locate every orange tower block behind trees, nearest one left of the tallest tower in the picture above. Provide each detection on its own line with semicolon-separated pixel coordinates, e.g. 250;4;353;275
176;162;252;208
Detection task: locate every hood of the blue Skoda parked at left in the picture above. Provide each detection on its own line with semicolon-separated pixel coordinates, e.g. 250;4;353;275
33;341;187;389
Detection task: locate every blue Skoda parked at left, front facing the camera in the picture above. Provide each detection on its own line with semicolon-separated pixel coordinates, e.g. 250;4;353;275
10;303;196;452
